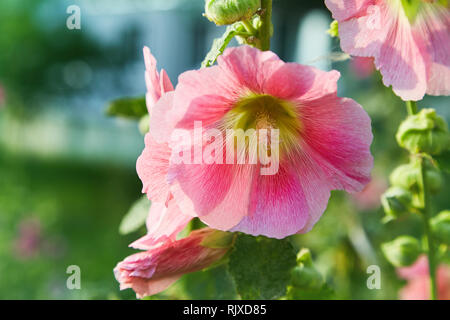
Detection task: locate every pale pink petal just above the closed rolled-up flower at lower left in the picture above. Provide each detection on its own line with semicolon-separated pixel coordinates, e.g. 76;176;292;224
130;199;192;250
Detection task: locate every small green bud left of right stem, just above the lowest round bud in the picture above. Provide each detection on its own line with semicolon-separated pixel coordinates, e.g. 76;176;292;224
381;187;412;218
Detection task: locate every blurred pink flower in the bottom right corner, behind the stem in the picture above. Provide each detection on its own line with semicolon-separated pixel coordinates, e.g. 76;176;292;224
397;255;450;300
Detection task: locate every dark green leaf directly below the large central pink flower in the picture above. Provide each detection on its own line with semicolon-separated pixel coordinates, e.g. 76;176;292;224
228;234;296;299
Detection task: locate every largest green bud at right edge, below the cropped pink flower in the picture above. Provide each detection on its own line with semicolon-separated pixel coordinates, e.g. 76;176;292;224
396;109;450;155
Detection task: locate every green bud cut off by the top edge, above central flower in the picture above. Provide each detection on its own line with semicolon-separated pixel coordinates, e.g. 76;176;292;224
205;0;261;26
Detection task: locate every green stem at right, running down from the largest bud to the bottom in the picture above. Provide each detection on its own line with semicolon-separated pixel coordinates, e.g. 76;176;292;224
421;158;437;300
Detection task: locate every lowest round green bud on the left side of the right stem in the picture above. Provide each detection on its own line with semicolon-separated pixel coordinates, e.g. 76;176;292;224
381;236;422;267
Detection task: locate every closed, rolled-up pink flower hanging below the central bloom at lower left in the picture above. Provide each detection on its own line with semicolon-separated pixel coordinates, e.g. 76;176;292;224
114;228;233;298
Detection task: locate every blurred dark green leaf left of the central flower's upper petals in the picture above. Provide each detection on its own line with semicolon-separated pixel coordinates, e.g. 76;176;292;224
106;97;148;120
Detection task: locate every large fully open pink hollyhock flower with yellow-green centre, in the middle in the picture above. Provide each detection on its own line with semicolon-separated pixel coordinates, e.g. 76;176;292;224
143;46;373;238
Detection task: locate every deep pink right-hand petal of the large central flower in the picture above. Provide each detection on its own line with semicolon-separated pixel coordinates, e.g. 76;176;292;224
298;94;373;192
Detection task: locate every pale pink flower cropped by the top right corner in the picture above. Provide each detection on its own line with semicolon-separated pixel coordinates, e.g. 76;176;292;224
325;0;450;100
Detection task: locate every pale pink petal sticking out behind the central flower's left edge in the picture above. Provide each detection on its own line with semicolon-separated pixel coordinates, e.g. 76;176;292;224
136;133;171;203
